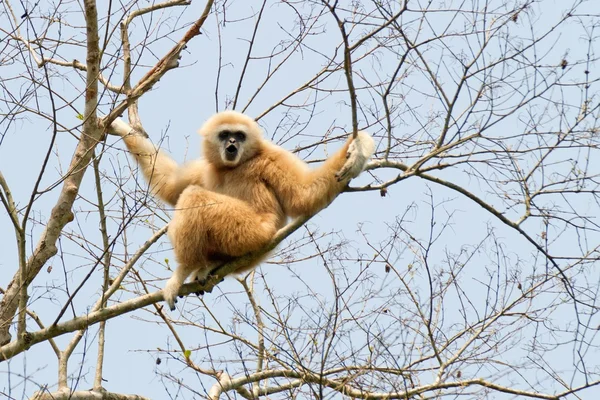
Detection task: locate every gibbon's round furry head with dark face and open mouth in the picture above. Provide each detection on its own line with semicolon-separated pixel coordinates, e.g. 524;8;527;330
200;111;262;168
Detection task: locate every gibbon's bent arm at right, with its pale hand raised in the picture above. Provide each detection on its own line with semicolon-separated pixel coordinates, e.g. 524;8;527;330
265;132;375;217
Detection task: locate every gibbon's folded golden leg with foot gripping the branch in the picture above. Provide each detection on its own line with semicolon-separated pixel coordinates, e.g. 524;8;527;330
164;186;277;310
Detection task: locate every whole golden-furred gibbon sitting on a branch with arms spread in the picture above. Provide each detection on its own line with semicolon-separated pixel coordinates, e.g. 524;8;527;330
112;111;375;310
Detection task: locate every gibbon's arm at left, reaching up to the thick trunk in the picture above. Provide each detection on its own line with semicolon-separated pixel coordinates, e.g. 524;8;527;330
111;120;205;206
